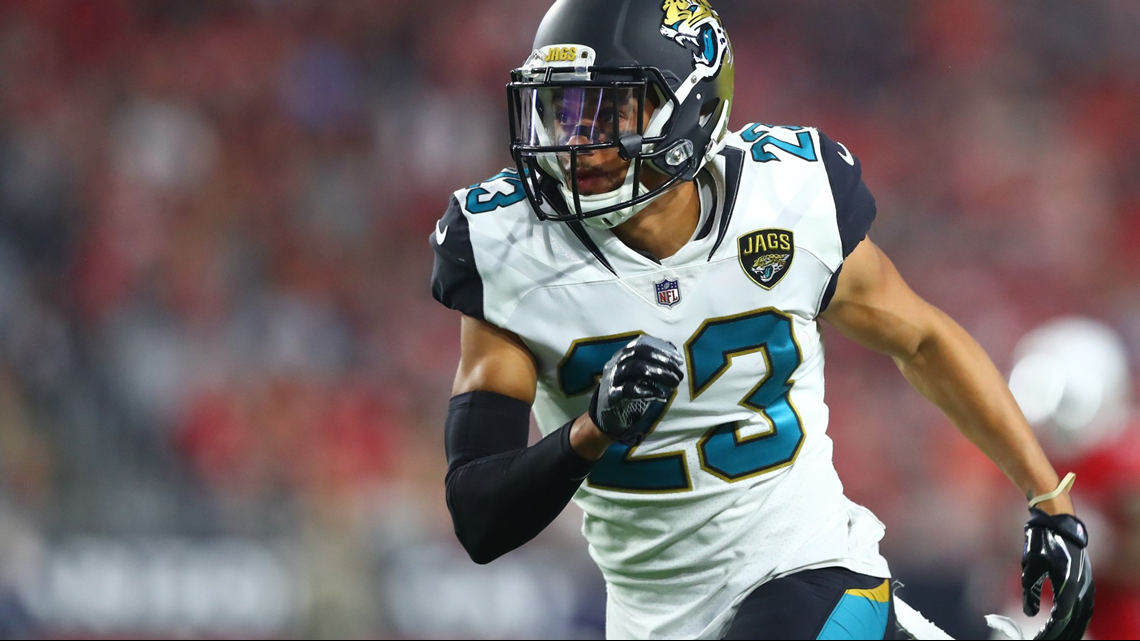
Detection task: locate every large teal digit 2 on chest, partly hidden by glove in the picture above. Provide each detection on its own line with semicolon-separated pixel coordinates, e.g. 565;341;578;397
559;332;692;493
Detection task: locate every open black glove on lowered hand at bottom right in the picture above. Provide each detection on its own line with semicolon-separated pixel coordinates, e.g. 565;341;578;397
1021;508;1096;639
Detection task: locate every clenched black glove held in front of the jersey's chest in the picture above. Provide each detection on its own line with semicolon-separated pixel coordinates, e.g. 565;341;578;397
589;335;685;445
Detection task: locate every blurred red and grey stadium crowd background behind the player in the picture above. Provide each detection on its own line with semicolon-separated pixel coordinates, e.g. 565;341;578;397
0;0;1140;638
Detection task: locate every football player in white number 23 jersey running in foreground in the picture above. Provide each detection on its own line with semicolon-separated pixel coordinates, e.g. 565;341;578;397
431;0;1092;639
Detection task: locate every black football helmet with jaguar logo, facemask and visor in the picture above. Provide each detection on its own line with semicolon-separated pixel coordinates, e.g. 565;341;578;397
507;0;734;227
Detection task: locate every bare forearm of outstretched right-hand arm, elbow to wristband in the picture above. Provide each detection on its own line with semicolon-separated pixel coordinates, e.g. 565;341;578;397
895;310;1073;513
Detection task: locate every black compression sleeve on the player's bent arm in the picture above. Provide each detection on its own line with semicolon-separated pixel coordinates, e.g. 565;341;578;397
446;391;594;563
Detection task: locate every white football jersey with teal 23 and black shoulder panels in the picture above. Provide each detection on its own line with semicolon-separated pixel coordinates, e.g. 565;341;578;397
432;124;889;639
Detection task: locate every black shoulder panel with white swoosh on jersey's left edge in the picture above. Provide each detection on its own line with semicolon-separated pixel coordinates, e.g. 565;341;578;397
430;197;485;321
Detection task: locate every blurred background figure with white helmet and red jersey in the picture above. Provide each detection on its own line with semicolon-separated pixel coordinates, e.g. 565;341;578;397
1010;317;1140;639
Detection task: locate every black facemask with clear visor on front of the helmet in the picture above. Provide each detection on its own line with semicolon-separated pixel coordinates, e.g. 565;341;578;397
507;54;703;227
